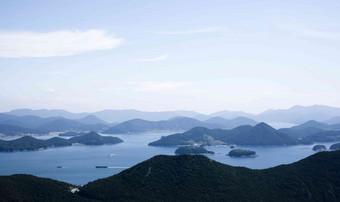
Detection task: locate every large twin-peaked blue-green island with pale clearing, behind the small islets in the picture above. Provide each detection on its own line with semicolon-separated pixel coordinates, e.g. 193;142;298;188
149;123;304;146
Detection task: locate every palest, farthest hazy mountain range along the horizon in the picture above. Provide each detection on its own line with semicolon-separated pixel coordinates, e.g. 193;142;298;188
6;105;340;124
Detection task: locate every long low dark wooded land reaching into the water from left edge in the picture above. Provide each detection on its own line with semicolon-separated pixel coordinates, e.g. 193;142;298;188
0;132;123;152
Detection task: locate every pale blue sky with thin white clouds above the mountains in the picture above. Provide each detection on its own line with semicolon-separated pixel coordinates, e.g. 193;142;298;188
0;0;340;113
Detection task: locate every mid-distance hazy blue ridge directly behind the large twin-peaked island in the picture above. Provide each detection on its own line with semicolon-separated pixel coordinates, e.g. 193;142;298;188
103;117;257;134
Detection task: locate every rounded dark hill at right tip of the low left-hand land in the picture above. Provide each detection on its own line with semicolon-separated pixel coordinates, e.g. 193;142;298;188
69;132;123;145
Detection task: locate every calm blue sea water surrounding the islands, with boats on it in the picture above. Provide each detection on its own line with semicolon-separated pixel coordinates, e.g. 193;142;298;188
0;133;334;185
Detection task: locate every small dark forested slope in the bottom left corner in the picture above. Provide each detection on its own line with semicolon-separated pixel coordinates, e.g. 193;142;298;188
0;175;89;202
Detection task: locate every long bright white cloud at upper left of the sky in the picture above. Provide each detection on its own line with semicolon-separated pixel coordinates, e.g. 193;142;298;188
0;29;123;58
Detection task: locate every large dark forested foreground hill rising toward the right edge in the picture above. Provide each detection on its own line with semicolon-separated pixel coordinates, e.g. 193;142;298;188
80;151;340;201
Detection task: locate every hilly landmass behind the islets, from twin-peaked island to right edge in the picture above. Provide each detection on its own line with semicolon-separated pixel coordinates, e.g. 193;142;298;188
149;120;340;146
